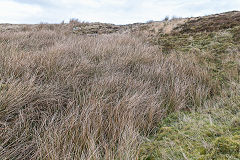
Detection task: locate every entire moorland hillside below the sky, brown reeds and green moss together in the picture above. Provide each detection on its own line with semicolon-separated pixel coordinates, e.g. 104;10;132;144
0;11;240;160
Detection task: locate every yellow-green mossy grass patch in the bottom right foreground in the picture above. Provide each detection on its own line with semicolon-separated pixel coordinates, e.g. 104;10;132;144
140;101;240;160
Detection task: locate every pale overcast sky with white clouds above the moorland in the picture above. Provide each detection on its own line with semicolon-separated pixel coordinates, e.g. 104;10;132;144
0;0;240;24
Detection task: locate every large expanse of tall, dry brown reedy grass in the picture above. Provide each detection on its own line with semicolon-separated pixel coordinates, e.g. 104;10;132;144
0;24;213;159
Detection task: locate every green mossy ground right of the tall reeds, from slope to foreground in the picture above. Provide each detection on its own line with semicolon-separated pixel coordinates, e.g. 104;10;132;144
140;12;240;160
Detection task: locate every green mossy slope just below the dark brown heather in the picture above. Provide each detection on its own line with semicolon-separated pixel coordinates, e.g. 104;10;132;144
154;26;240;86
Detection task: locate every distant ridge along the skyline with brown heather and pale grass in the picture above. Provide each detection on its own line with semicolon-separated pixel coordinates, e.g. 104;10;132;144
0;11;240;35
